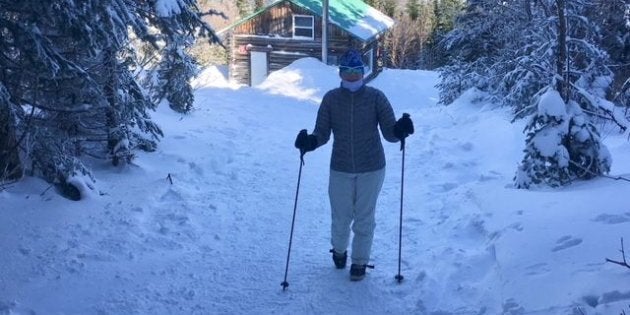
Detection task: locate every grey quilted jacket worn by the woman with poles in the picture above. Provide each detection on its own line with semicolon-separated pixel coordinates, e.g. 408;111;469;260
313;85;398;173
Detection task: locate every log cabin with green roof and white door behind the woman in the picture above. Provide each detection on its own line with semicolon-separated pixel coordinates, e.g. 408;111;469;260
218;0;394;86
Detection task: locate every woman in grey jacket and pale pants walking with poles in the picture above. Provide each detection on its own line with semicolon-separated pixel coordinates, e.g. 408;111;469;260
295;49;414;281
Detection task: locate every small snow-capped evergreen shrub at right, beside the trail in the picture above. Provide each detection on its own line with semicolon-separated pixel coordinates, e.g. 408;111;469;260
514;86;612;188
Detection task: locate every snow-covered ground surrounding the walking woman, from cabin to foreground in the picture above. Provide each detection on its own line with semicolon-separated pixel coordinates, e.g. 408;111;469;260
0;58;630;315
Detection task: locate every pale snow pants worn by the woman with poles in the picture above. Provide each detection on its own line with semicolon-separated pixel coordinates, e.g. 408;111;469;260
328;168;385;265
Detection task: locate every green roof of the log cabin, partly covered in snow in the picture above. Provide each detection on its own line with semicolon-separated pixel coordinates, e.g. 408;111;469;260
218;0;394;41
